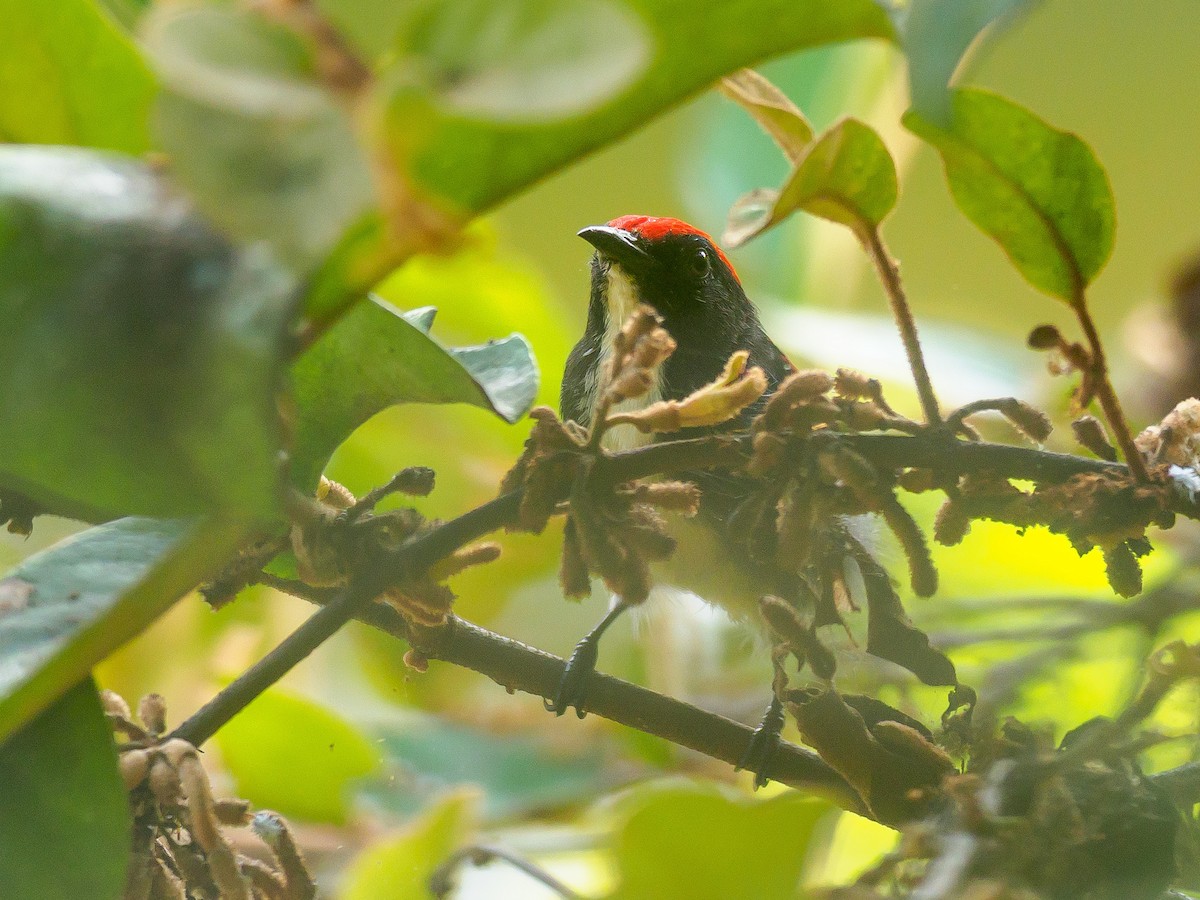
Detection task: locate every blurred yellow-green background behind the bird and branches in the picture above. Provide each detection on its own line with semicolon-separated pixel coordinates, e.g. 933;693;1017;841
7;0;1200;898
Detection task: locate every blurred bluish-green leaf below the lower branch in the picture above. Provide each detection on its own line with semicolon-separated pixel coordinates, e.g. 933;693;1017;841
350;713;612;821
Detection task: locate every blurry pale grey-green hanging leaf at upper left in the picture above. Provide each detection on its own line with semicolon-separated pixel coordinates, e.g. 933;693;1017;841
145;6;372;271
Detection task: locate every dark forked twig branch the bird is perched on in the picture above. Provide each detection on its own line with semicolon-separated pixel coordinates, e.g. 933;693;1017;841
172;432;1185;787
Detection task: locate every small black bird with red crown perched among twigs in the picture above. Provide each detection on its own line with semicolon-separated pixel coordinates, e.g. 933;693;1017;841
547;215;796;779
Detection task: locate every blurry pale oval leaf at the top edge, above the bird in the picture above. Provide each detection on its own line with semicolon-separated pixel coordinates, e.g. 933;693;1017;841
404;0;652;122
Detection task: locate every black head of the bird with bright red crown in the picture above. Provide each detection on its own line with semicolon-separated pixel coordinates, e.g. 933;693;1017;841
580;216;751;336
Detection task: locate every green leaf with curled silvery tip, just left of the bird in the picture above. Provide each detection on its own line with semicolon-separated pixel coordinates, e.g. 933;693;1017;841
292;298;538;488
